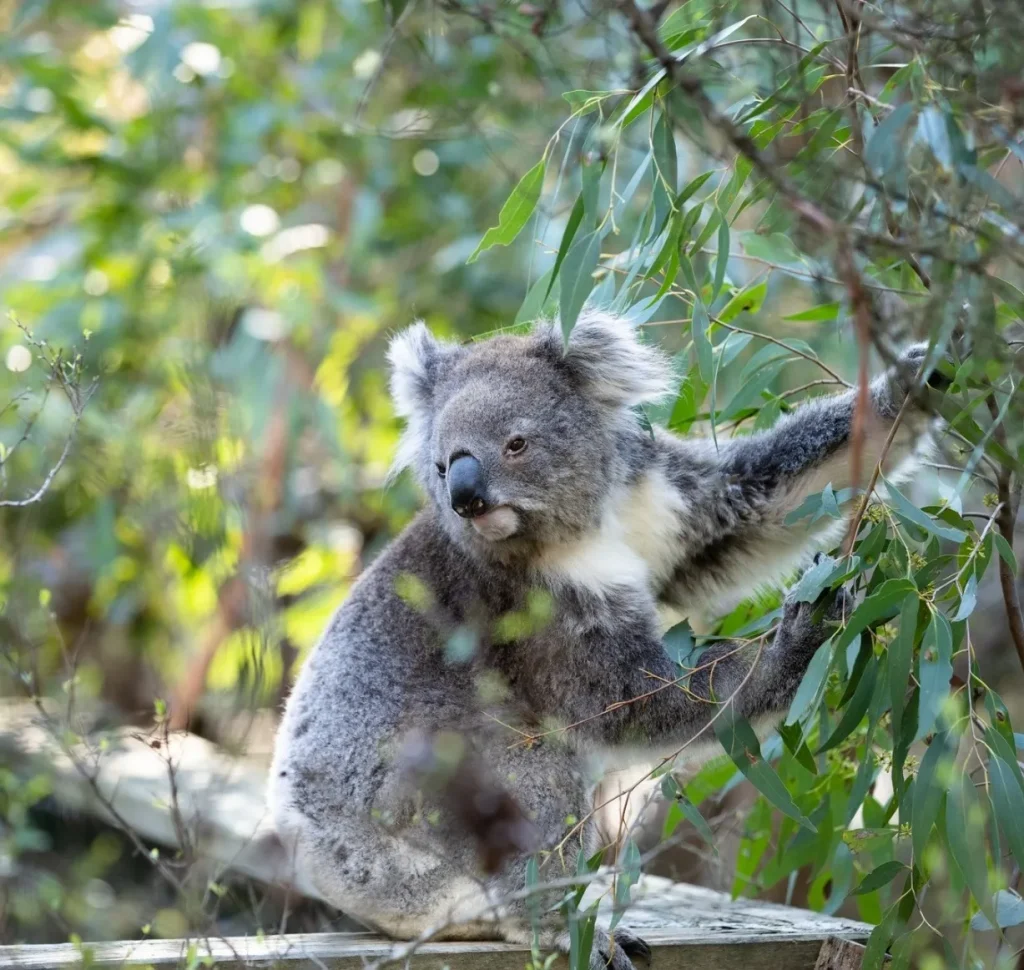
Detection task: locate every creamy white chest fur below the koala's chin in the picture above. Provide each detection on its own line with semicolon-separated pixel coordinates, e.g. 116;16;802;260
539;469;684;596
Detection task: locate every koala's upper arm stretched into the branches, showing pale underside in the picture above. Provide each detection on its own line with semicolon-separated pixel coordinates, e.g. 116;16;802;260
658;346;931;606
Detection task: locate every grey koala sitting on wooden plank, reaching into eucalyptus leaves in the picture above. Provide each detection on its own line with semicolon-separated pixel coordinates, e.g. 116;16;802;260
269;308;931;970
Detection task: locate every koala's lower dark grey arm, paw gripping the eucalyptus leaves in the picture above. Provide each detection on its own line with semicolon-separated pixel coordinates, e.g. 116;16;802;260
535;590;852;760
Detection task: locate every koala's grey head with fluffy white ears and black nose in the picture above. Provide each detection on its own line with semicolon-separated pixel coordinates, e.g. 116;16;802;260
388;310;671;557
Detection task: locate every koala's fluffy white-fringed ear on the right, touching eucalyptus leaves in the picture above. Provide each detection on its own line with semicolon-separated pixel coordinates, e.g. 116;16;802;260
559;307;674;407
